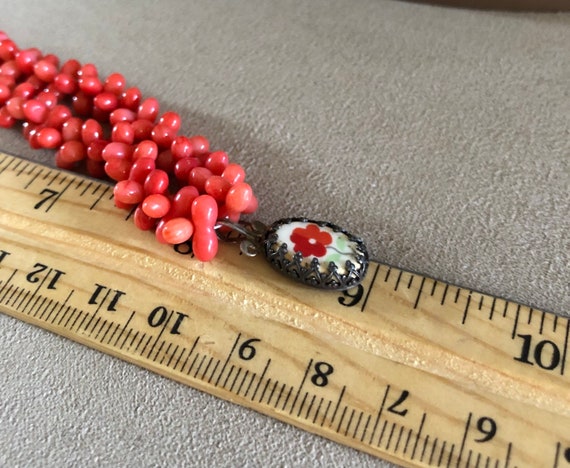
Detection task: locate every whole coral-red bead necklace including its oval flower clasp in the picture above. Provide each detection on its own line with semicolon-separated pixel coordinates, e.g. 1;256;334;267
0;31;368;289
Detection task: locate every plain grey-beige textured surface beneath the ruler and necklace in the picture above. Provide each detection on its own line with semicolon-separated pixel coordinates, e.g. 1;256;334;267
0;0;570;467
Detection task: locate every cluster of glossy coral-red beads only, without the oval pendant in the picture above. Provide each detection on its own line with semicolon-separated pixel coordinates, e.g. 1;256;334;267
0;32;257;261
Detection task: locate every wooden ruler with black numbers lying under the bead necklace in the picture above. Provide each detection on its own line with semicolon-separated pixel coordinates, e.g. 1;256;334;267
0;154;570;468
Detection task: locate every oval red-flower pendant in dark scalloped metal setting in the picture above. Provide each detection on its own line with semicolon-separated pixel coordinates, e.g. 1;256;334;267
263;218;368;290
